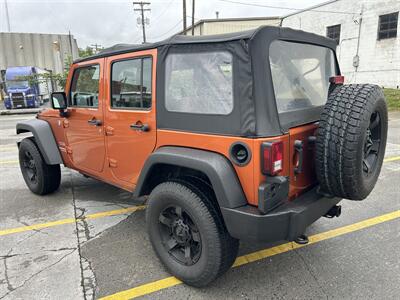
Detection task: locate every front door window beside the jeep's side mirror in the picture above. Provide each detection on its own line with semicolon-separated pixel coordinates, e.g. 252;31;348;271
69;65;100;107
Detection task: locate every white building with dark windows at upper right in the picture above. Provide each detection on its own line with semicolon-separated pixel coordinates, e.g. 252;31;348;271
282;0;400;88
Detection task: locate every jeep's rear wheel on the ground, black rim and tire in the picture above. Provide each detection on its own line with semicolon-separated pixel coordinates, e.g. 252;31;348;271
146;182;239;287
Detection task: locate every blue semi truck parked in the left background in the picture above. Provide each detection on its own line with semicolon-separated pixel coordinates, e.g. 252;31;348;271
4;67;52;109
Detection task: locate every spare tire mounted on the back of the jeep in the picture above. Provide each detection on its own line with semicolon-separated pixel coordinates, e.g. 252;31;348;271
316;84;388;200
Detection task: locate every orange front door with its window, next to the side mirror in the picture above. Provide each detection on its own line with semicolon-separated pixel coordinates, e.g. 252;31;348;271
64;59;105;174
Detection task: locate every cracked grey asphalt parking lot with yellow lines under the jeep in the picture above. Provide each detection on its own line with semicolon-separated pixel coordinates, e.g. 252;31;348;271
0;113;400;299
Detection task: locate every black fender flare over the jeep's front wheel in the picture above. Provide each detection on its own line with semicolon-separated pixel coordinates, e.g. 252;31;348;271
16;119;63;165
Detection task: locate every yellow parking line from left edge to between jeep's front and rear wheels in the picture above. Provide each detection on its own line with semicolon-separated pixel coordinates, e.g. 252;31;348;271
0;205;145;236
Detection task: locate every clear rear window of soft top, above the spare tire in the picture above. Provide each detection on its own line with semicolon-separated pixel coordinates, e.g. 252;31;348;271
269;40;336;113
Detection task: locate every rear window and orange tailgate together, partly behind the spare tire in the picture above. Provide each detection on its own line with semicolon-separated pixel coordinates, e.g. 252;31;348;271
270;40;336;198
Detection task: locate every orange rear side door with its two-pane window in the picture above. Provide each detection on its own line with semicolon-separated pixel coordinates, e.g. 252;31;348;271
105;50;157;187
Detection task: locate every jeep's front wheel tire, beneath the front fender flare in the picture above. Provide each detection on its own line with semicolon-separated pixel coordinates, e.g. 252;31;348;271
19;138;61;195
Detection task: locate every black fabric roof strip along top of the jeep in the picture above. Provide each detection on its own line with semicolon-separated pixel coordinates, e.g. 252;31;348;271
74;26;336;63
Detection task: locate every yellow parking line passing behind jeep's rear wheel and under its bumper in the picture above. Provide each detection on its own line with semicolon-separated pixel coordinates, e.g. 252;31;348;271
100;210;400;300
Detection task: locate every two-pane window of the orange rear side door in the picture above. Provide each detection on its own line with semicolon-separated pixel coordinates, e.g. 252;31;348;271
111;57;152;109
